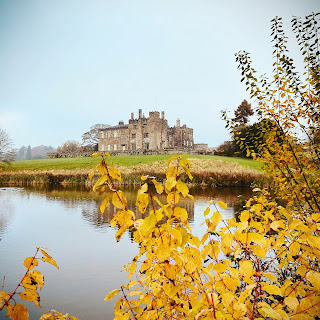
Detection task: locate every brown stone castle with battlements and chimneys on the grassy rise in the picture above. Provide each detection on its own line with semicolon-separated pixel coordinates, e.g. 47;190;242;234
98;109;194;152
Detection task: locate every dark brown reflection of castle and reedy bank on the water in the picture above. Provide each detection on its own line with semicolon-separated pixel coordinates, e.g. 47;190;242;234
26;186;251;231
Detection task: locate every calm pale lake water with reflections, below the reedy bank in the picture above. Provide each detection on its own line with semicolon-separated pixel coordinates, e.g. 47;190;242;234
0;187;251;320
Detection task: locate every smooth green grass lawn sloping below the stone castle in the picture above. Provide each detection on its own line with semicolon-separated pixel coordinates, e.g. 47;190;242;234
5;155;261;171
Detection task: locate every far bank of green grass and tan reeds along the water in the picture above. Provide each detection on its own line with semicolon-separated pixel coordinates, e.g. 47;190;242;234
0;156;263;187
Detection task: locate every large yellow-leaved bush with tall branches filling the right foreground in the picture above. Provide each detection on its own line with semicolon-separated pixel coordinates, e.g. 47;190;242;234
92;14;320;320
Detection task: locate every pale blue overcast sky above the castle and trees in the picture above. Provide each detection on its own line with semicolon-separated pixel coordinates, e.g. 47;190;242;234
0;0;320;148
